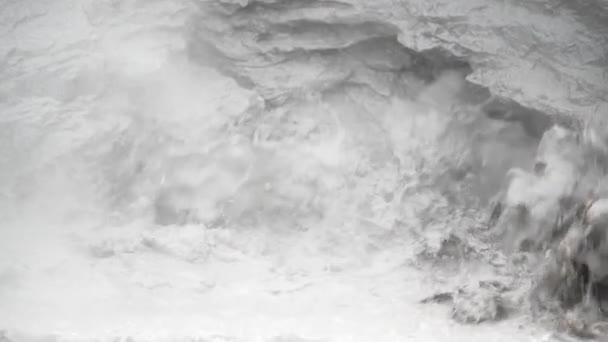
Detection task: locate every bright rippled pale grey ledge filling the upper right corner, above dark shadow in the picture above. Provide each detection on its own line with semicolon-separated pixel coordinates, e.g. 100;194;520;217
374;0;608;116
